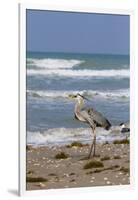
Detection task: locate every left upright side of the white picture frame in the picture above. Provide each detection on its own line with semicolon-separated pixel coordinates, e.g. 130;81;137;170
19;5;26;196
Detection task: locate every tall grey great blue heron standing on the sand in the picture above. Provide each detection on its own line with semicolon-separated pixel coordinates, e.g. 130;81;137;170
71;94;111;159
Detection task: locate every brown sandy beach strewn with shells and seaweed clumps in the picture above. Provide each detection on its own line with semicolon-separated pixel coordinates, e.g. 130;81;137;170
26;140;130;190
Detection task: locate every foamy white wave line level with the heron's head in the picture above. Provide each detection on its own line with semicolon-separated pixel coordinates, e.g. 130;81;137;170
27;89;129;100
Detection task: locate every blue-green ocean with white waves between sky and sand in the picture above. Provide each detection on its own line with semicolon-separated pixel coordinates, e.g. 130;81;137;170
26;52;130;145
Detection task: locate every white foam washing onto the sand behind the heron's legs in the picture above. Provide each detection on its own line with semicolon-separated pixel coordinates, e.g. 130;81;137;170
27;126;128;145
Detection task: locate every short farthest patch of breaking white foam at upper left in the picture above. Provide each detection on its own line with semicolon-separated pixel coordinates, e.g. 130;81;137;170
27;58;84;70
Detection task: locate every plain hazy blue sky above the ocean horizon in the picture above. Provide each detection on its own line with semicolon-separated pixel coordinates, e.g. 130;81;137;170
27;10;130;54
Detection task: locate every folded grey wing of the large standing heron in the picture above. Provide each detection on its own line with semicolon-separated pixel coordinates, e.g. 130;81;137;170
81;108;111;129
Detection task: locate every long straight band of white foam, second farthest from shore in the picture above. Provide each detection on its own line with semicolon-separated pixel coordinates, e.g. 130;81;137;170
27;69;130;78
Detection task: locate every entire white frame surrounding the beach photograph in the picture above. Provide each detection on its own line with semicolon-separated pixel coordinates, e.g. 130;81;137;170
19;2;135;196
